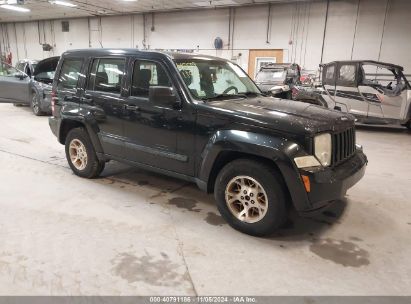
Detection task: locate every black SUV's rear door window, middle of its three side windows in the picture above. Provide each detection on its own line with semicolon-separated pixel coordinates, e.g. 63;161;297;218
87;58;125;93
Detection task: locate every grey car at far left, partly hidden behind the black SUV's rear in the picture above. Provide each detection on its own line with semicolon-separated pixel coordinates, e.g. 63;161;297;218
0;57;60;115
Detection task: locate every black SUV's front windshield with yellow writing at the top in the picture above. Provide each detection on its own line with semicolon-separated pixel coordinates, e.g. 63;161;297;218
175;58;260;100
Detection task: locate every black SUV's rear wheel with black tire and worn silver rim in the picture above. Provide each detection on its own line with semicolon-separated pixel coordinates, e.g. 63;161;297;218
65;128;105;178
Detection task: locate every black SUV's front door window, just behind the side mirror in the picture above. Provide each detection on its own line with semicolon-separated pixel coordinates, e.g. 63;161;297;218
131;60;171;97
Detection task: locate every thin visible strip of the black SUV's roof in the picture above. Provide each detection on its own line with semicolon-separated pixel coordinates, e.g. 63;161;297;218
63;48;226;61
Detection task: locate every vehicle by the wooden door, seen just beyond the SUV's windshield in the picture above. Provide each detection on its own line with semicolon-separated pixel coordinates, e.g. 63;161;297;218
255;63;301;99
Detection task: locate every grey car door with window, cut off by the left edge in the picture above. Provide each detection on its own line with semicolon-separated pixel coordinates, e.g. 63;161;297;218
0;62;31;104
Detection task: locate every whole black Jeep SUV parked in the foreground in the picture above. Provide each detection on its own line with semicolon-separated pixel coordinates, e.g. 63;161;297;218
49;49;367;236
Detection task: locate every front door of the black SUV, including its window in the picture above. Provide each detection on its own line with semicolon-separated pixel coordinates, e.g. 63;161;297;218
124;59;194;175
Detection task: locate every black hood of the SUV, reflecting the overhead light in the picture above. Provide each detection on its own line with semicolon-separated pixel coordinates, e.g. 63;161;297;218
207;97;354;134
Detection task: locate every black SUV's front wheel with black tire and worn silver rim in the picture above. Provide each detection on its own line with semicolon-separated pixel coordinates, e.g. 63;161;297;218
214;159;287;236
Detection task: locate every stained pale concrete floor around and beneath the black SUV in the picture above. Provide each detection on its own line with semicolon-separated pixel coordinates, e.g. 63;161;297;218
0;104;411;295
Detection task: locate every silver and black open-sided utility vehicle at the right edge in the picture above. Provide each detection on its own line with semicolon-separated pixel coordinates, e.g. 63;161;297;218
317;61;411;129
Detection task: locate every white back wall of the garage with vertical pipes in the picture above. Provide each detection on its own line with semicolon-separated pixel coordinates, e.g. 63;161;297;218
0;0;411;73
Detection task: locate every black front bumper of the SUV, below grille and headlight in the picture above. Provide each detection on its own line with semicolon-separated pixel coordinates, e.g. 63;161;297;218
299;149;368;212
